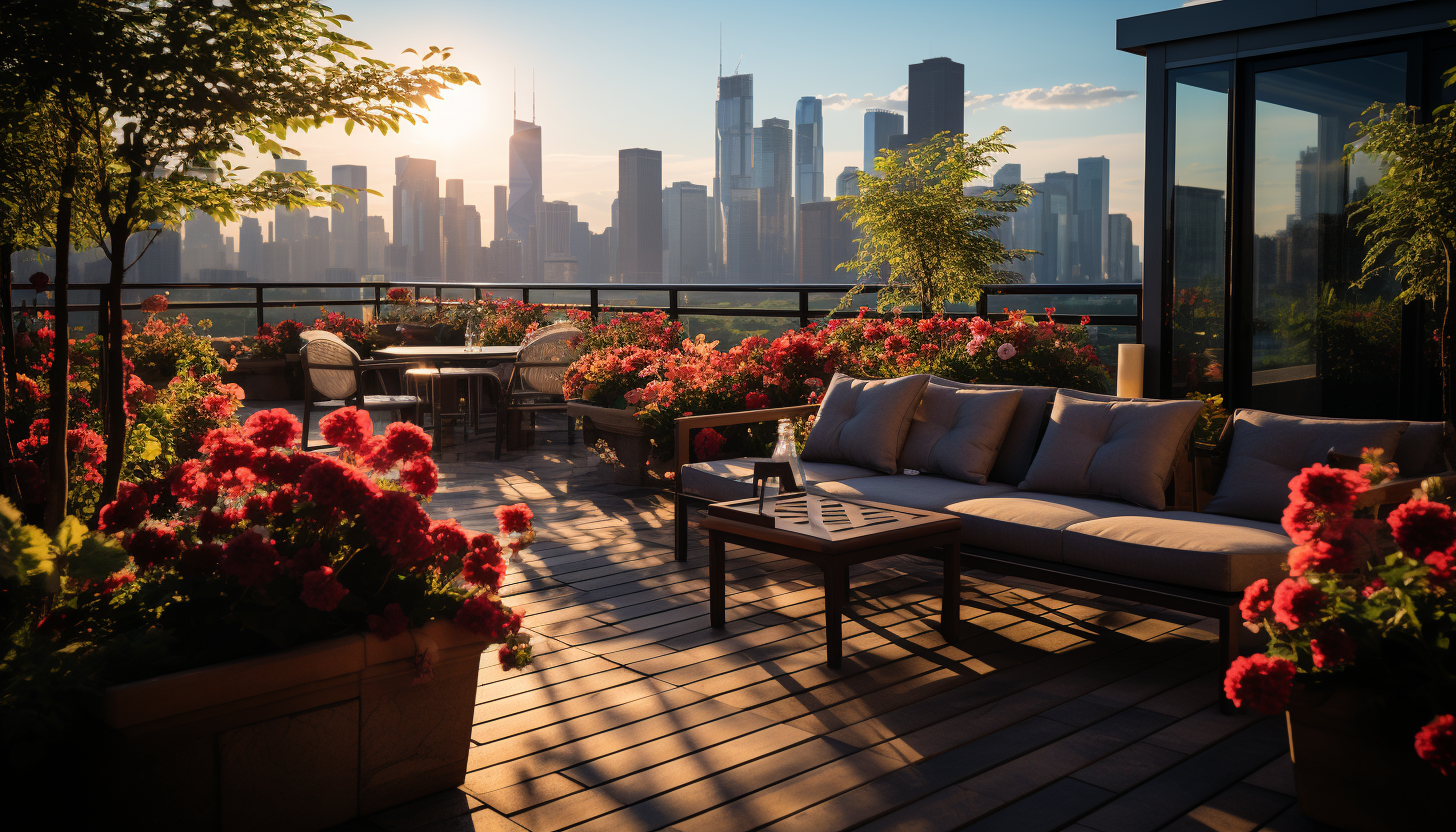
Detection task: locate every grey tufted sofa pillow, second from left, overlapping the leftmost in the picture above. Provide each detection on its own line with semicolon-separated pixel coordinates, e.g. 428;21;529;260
900;380;1021;485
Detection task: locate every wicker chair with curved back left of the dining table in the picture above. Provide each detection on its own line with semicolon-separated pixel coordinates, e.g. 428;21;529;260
298;329;419;450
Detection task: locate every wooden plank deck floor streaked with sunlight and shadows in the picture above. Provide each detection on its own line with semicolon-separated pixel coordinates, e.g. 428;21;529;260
313;413;1322;832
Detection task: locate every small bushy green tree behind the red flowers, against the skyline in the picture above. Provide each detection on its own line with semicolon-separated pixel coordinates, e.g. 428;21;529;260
837;127;1035;315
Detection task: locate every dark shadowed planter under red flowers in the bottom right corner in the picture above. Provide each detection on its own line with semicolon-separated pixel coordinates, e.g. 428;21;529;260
1286;686;1456;832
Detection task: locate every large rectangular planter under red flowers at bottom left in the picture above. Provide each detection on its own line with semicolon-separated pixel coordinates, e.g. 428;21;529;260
103;621;485;831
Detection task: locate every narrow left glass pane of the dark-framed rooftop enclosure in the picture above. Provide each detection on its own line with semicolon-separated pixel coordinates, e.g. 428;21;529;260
1169;68;1229;396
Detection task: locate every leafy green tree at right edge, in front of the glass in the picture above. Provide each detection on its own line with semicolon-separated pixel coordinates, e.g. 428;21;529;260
1345;87;1456;441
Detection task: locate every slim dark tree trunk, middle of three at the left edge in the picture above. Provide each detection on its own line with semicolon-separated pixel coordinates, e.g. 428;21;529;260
45;121;80;535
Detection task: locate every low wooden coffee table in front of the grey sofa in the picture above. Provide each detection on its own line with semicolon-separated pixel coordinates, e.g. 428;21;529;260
703;494;961;667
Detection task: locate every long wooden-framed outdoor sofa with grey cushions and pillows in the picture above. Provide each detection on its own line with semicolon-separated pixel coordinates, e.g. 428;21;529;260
676;376;1450;673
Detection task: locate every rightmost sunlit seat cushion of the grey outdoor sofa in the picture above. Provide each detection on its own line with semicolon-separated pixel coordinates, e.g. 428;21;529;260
1061;511;1294;592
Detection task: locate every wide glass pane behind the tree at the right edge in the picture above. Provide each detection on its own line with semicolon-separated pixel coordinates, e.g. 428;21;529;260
1251;54;1405;417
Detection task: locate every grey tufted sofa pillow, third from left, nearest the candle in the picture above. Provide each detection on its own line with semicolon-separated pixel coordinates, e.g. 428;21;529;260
1021;391;1203;511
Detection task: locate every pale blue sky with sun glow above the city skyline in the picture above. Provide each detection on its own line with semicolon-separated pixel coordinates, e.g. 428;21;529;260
247;0;1181;250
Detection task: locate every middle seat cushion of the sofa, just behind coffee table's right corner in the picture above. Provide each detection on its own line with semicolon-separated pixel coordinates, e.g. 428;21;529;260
945;491;1159;562
